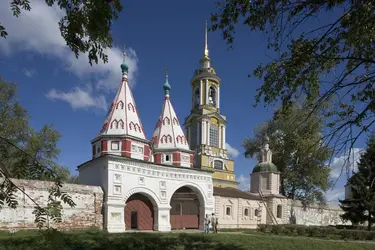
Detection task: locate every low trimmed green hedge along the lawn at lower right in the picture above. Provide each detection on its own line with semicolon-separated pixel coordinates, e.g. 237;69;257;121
258;224;375;240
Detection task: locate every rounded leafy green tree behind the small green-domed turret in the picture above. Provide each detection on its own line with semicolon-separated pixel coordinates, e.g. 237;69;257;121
243;101;331;206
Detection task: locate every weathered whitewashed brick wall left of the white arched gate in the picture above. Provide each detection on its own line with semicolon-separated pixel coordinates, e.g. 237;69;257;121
0;179;103;230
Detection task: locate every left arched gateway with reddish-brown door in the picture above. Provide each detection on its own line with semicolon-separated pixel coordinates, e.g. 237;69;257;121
125;193;154;230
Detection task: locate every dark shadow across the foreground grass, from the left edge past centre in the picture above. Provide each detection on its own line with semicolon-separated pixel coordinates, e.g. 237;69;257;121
0;231;244;250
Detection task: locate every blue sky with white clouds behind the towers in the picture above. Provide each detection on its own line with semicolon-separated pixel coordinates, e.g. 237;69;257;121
0;0;365;203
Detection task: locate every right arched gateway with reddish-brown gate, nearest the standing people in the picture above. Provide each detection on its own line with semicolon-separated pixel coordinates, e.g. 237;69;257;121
170;186;204;229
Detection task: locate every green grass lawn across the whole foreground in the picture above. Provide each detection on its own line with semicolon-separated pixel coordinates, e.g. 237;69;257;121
0;231;375;250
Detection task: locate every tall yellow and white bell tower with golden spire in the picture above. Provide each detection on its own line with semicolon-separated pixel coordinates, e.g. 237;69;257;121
184;22;238;188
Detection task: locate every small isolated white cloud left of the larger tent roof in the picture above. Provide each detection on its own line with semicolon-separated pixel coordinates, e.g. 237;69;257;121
46;87;108;110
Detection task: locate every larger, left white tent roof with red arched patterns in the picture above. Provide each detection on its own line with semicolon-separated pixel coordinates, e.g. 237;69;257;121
100;75;146;140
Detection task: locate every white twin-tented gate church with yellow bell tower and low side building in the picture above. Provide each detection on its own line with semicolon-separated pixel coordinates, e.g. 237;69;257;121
78;24;324;232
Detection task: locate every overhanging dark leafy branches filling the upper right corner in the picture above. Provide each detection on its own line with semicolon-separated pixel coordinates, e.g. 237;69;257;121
211;0;375;174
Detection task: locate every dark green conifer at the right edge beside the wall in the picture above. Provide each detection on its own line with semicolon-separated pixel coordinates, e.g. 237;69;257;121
340;134;375;231
